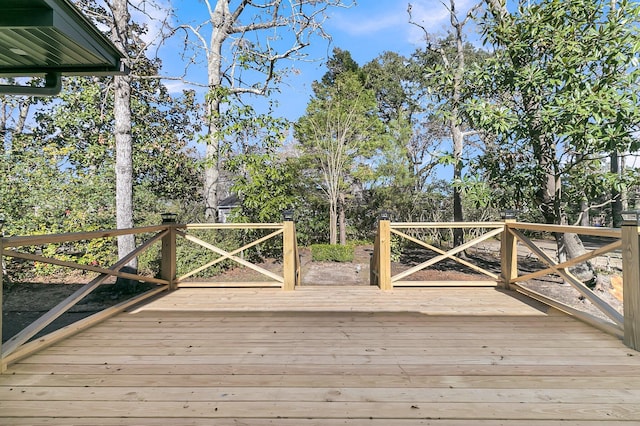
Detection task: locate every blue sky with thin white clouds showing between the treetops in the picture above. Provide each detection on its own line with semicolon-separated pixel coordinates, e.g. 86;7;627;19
145;0;482;120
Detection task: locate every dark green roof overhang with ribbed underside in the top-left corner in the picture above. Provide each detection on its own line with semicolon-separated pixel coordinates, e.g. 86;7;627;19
0;0;127;93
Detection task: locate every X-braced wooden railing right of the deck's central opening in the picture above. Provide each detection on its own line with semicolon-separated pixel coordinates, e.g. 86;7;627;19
371;219;640;350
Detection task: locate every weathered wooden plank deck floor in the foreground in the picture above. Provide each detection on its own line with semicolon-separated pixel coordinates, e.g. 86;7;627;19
0;286;640;426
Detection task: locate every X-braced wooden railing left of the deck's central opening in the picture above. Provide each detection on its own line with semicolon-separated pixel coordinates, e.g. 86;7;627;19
0;221;300;372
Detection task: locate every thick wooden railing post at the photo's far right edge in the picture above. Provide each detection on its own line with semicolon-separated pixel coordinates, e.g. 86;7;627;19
622;218;640;351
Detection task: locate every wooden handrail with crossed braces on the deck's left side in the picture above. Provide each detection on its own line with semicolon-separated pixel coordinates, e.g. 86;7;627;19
0;222;301;372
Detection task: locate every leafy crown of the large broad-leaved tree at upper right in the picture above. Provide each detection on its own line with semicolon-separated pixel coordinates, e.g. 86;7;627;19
467;0;640;223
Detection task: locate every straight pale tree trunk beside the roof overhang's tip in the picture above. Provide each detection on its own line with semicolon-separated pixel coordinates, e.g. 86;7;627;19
111;0;138;270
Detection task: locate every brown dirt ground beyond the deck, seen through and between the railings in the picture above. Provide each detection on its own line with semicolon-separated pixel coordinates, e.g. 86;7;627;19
2;246;622;341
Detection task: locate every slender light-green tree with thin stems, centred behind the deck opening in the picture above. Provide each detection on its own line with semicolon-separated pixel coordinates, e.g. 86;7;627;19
294;51;387;243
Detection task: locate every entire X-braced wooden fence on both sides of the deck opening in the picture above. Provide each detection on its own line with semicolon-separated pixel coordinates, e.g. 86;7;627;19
0;216;640;371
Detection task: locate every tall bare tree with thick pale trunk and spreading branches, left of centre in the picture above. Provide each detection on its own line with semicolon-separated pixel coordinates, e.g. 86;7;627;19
174;0;347;219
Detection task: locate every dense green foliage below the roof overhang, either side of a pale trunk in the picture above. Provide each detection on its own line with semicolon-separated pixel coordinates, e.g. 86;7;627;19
0;60;201;274
